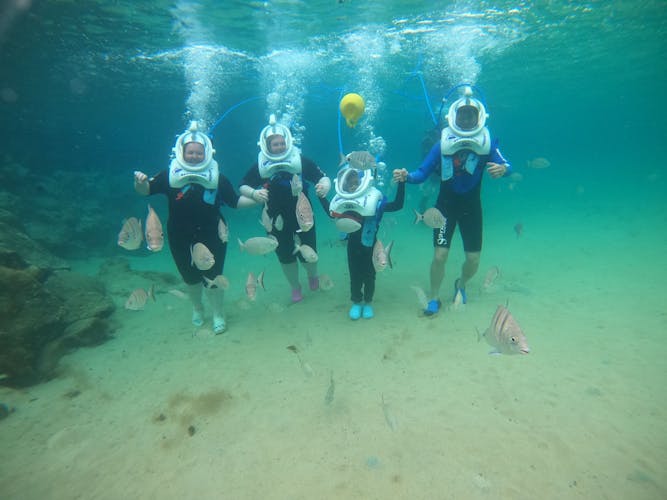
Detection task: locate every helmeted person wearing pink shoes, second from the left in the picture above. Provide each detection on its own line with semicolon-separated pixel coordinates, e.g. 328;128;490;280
239;115;331;302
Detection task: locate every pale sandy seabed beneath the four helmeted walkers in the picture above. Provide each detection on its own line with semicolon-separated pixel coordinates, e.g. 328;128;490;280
0;192;667;499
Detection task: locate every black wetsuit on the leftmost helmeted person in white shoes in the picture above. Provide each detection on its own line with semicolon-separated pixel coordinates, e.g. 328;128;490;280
149;170;239;285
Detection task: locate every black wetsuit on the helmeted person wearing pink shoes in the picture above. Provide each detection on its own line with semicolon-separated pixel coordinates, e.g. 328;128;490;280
240;155;326;264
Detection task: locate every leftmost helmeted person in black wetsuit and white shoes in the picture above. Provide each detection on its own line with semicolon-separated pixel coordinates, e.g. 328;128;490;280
134;122;256;334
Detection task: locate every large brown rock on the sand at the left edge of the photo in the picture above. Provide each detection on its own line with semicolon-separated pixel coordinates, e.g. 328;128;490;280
0;218;114;386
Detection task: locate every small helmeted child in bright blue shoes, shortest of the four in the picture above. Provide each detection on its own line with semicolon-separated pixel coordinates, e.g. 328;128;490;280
328;165;405;320
